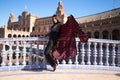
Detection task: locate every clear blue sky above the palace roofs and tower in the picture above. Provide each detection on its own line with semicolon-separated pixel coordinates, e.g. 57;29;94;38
0;0;120;26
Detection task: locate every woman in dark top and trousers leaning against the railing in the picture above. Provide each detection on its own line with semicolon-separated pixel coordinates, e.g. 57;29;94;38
44;15;61;71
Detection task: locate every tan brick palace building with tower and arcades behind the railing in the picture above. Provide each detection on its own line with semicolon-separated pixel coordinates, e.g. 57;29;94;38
0;1;120;40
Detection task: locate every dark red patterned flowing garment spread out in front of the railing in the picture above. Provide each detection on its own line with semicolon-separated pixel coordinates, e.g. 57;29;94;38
52;15;88;60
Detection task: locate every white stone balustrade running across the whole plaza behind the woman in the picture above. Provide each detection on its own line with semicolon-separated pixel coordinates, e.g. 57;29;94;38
0;37;120;71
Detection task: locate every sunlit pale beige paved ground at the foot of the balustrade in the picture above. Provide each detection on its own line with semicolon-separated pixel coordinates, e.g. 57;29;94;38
0;69;120;80
